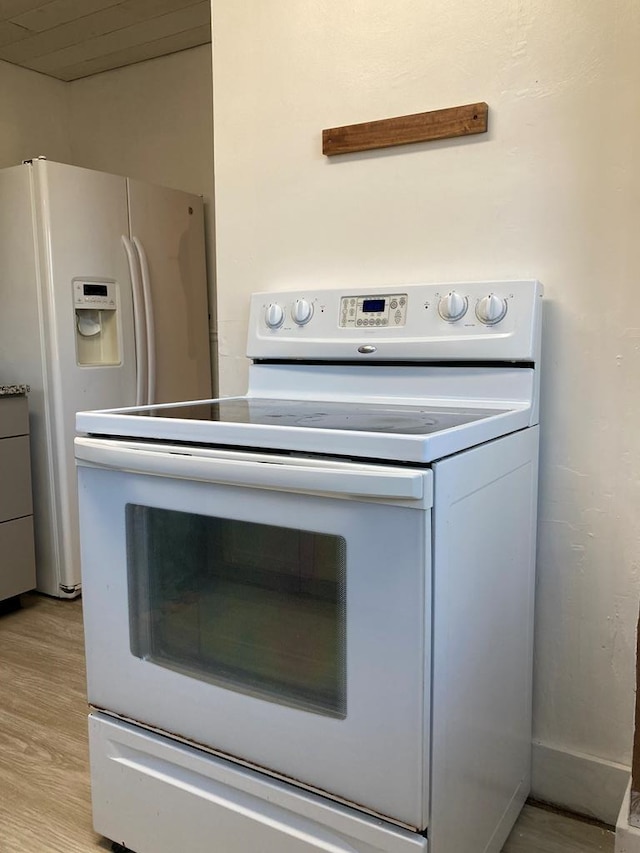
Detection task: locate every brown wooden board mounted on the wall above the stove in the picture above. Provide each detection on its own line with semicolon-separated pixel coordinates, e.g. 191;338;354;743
322;101;489;157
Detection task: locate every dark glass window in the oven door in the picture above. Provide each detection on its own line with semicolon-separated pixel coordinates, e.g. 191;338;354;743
126;504;347;719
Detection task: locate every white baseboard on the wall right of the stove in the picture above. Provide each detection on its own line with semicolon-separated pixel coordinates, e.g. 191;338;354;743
531;742;640;824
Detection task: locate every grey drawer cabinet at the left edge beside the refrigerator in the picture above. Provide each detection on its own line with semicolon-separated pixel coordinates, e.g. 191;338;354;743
0;395;36;601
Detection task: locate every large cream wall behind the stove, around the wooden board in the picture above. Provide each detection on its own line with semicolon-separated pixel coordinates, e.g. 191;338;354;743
212;0;640;817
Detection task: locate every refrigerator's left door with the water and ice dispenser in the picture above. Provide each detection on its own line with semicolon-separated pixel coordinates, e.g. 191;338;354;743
31;160;136;596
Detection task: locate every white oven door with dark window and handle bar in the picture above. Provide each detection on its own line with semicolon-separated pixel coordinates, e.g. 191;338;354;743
76;438;432;829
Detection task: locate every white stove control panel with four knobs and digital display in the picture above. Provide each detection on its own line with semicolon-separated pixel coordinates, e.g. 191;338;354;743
247;279;542;361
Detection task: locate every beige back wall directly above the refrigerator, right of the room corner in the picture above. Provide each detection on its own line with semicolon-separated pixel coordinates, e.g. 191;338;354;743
68;45;215;382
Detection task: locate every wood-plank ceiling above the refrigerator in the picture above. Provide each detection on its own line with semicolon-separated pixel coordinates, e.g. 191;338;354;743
0;0;211;81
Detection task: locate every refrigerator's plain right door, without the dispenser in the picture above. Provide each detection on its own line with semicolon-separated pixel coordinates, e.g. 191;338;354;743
127;179;212;403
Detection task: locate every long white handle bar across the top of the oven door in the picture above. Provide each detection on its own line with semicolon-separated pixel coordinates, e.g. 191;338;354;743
75;438;431;506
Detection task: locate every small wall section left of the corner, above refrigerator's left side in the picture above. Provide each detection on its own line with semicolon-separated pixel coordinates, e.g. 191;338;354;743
0;60;70;168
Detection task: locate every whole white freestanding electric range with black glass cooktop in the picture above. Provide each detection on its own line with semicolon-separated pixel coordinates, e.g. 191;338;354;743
76;281;542;853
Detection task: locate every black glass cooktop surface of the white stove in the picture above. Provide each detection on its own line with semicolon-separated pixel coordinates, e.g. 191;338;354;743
132;397;507;435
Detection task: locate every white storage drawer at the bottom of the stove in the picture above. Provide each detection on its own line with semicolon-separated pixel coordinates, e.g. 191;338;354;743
89;713;428;853
